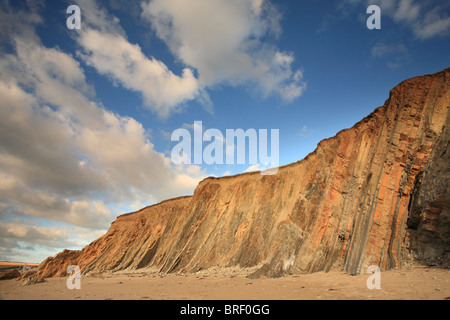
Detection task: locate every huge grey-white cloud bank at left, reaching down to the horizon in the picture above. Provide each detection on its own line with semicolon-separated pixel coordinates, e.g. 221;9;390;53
0;3;204;257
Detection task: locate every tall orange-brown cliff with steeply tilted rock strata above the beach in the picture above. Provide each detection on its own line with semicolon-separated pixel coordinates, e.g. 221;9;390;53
39;68;450;277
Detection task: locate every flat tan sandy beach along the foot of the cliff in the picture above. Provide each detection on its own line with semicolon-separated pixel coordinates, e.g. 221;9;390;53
0;267;450;300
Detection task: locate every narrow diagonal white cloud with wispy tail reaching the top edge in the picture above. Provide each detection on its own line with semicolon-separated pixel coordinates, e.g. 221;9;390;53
76;0;210;118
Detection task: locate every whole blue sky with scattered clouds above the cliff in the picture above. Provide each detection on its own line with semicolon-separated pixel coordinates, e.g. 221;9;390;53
0;0;450;262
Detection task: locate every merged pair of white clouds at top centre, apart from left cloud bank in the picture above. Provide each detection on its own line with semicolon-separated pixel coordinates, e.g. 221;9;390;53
71;0;306;118
